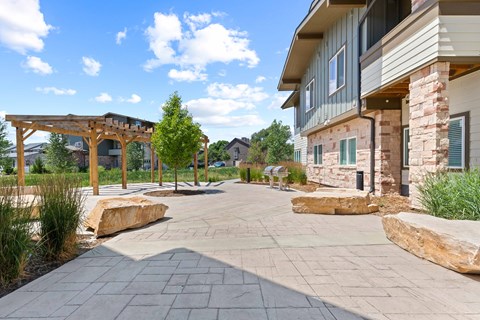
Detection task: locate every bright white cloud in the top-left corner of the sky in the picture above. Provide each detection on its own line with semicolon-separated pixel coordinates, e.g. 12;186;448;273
0;0;52;54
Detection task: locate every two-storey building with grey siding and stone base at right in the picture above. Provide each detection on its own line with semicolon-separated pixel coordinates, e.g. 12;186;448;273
278;0;480;206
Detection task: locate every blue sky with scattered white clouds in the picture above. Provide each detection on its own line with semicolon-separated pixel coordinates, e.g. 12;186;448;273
0;0;311;143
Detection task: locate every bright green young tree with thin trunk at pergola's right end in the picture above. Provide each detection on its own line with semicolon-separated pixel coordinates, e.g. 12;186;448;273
152;91;202;192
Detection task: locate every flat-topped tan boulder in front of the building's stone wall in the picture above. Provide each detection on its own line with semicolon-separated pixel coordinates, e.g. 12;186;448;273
292;188;378;214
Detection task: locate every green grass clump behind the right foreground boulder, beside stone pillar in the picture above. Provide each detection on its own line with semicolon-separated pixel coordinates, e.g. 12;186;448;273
419;169;480;220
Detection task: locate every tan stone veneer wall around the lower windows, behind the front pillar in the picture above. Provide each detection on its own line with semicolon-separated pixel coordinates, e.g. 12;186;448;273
307;110;401;194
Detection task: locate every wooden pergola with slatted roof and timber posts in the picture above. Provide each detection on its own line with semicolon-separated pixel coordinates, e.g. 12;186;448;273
5;114;209;195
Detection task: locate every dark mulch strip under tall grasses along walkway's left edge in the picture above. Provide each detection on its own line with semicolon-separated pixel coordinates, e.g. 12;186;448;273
0;236;112;298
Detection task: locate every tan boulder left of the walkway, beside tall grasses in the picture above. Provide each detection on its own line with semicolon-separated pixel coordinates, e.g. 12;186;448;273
84;197;168;236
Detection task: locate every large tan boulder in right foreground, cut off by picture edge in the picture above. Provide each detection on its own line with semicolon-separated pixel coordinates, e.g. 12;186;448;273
382;212;480;274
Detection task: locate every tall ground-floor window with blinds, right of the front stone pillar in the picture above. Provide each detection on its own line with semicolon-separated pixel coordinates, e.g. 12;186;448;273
448;116;465;169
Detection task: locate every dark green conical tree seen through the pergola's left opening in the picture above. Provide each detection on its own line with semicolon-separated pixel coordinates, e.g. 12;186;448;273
46;133;77;173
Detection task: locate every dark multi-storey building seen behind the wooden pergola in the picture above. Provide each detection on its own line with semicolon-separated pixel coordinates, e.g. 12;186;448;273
67;112;156;169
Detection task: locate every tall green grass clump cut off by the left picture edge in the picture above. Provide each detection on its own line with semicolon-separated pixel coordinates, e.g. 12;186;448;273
0;178;32;286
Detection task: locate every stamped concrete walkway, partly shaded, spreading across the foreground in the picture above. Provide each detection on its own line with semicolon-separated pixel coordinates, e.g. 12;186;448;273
0;182;480;320
